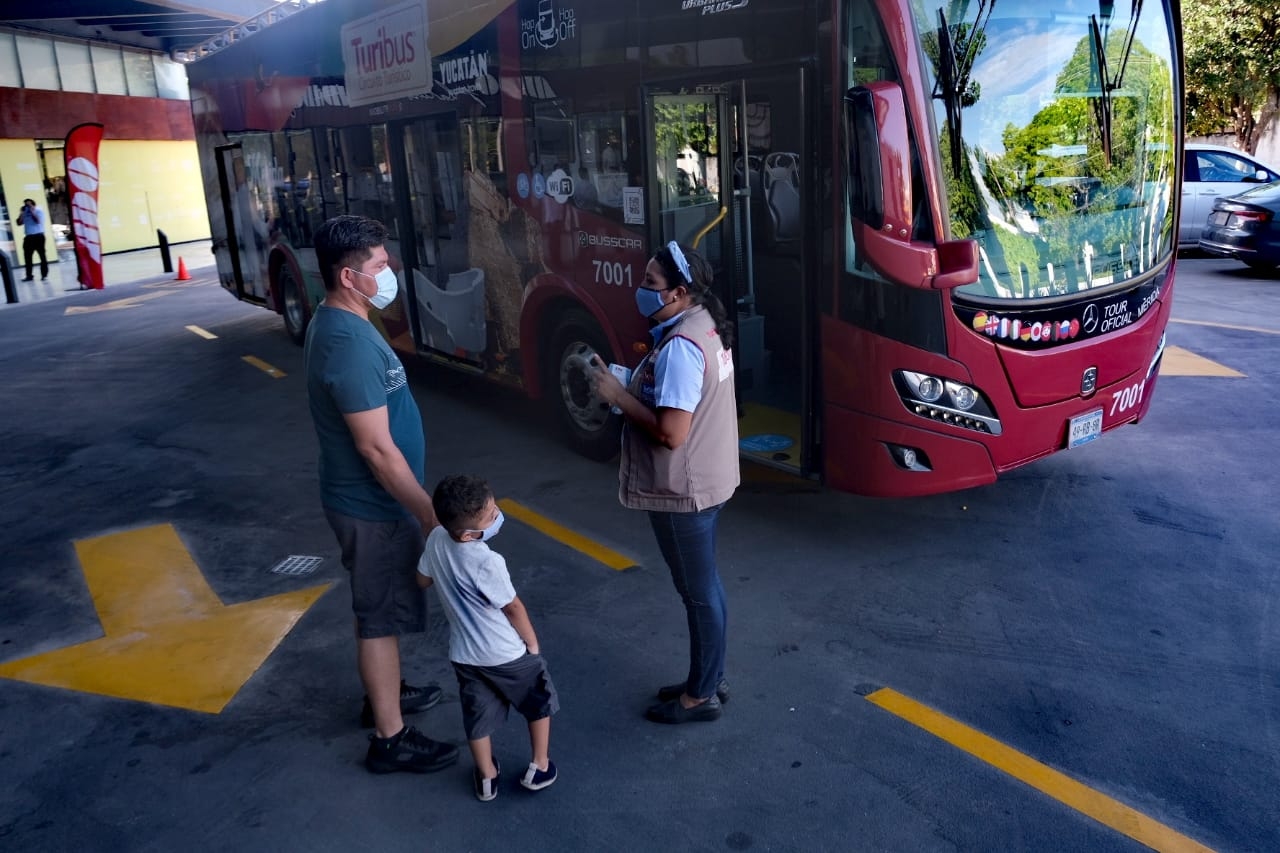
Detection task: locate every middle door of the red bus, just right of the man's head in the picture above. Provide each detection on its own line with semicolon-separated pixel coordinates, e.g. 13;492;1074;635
401;114;488;365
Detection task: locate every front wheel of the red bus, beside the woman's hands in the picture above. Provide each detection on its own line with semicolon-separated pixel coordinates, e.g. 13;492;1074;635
545;313;622;461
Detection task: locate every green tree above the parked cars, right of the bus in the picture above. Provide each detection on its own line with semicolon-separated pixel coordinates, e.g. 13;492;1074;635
1183;0;1280;154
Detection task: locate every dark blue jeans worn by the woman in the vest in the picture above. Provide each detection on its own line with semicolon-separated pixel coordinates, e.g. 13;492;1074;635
649;503;727;699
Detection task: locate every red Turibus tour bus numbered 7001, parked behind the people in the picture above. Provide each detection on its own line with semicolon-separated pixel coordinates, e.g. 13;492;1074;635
180;0;1183;496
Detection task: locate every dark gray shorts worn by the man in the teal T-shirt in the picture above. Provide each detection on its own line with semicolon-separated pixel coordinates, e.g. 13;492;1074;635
324;508;426;639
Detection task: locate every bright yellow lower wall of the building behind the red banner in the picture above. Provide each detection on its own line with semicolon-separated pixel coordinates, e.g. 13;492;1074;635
0;140;209;261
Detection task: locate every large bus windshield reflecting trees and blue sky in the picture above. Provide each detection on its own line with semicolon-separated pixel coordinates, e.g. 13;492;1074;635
911;0;1176;301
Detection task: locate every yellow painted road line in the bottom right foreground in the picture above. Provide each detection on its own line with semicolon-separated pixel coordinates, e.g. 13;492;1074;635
867;688;1212;853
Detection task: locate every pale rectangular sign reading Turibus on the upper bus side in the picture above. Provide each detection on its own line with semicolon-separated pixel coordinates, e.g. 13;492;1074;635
342;0;431;106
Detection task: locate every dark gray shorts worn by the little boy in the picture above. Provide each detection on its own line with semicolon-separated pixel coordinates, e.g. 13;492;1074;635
453;654;559;740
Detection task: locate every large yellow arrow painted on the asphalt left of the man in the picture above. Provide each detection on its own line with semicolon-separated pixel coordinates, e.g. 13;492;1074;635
0;524;332;713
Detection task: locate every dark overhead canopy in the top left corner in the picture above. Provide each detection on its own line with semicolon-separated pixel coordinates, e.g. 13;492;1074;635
0;0;282;55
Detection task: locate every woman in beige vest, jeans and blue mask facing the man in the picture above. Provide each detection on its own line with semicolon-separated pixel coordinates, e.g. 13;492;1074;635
594;241;739;724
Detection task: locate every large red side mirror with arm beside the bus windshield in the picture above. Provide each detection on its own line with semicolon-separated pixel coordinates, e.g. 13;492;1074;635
845;81;978;288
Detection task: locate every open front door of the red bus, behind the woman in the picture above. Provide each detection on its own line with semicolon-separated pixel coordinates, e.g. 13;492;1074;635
646;70;815;474
